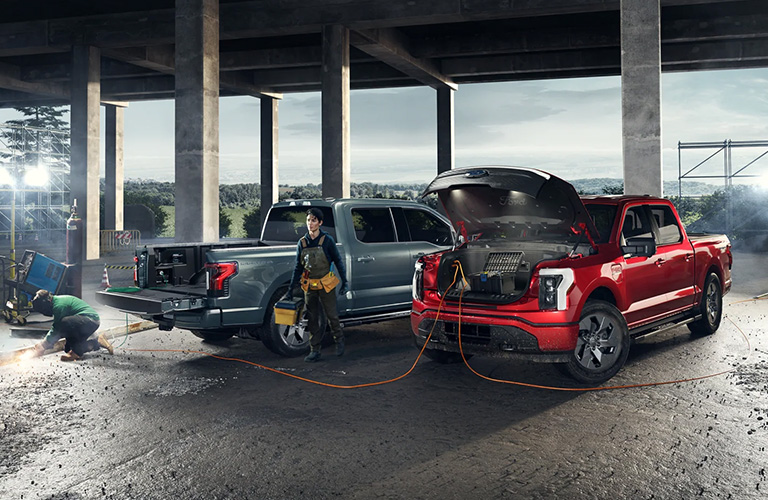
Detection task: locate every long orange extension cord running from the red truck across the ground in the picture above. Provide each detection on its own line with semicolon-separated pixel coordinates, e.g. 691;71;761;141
126;261;756;392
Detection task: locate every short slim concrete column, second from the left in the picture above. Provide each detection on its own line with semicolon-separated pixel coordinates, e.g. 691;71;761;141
104;104;124;231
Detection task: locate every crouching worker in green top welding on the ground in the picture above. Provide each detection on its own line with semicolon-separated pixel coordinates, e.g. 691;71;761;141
32;290;115;361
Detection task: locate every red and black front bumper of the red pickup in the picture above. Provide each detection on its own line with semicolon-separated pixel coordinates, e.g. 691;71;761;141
411;310;579;363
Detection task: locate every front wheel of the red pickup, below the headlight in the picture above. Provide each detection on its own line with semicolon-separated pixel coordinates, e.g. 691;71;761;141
564;300;629;385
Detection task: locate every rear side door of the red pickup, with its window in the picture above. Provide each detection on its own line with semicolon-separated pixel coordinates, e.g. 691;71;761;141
650;205;695;312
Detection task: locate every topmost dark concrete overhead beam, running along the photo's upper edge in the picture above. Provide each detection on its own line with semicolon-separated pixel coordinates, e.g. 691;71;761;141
0;0;756;57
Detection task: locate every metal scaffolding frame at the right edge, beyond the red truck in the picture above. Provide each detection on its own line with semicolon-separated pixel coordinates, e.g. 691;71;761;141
677;139;768;234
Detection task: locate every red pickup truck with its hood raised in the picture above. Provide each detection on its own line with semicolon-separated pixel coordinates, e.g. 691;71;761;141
411;167;733;384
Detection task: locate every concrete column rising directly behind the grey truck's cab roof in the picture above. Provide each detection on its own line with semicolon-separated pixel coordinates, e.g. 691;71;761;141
322;26;350;198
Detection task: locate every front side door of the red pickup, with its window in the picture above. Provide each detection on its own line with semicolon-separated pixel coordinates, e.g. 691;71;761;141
620;205;668;325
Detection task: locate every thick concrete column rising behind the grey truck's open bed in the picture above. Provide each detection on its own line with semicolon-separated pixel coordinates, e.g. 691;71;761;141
175;0;219;242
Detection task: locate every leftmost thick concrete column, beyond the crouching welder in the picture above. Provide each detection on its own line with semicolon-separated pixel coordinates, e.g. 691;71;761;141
69;46;101;264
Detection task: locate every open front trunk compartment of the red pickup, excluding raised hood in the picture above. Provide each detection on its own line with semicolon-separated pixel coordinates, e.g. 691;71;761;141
437;242;571;304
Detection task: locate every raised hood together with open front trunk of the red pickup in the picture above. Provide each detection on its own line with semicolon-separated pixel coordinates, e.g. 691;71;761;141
424;167;598;303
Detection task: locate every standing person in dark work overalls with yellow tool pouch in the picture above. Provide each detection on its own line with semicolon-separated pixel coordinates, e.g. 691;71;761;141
284;208;347;363
